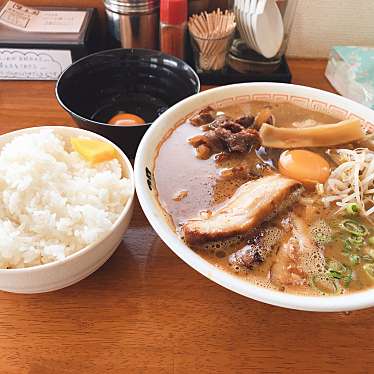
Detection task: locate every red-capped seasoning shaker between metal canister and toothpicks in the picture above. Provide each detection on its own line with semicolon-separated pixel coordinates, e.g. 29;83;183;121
160;0;188;60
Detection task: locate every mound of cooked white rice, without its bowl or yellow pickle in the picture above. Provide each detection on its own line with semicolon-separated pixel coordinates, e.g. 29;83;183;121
0;129;131;268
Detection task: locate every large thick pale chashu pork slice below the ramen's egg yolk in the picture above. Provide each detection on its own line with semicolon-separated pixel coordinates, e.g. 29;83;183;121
182;175;303;245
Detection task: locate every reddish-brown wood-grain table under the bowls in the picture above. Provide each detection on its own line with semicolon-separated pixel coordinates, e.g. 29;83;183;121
0;60;374;374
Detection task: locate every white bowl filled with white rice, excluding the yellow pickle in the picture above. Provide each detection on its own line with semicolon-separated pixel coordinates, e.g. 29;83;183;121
0;126;135;293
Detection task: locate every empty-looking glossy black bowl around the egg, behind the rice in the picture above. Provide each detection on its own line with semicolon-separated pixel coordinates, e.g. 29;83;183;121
56;49;200;158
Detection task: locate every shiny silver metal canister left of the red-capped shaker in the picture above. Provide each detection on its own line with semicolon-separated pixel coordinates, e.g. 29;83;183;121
104;0;160;49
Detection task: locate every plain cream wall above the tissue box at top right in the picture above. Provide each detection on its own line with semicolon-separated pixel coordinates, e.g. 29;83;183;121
287;0;374;57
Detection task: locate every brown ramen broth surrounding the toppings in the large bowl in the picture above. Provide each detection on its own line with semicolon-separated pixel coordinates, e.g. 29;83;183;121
154;101;373;295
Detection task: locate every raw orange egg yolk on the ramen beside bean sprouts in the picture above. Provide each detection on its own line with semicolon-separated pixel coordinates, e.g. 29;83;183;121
278;149;330;188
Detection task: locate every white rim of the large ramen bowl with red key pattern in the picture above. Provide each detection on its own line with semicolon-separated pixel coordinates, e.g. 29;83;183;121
135;83;374;312
